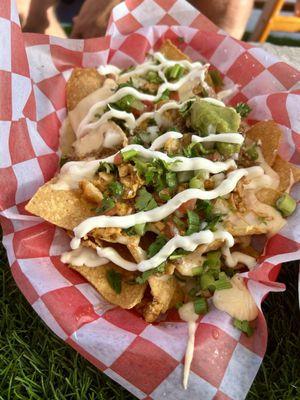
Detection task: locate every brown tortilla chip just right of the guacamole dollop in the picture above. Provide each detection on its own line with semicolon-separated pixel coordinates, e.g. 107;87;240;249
246;121;282;166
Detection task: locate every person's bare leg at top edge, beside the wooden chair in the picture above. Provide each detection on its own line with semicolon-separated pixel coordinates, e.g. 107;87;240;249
190;0;254;39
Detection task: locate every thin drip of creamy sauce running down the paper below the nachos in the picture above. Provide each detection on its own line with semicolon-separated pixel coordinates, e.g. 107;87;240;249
178;301;199;389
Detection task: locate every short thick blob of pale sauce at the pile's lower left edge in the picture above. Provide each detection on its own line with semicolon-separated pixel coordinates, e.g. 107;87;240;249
60;246;109;268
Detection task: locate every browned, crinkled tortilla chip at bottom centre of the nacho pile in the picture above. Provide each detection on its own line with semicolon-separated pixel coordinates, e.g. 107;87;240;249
143;275;182;322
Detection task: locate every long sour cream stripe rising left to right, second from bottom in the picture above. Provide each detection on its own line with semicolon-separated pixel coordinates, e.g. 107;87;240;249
71;169;247;244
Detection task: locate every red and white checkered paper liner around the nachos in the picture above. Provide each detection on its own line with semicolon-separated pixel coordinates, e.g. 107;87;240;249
0;0;300;400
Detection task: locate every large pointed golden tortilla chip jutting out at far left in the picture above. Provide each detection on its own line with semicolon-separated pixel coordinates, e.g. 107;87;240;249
25;179;95;230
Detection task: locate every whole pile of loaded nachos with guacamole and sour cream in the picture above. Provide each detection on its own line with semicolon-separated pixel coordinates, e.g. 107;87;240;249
26;41;300;385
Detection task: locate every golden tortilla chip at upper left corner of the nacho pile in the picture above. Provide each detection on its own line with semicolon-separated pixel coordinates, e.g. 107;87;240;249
66;68;106;111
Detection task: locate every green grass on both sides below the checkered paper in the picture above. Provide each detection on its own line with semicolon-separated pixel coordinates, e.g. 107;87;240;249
0;236;300;400
